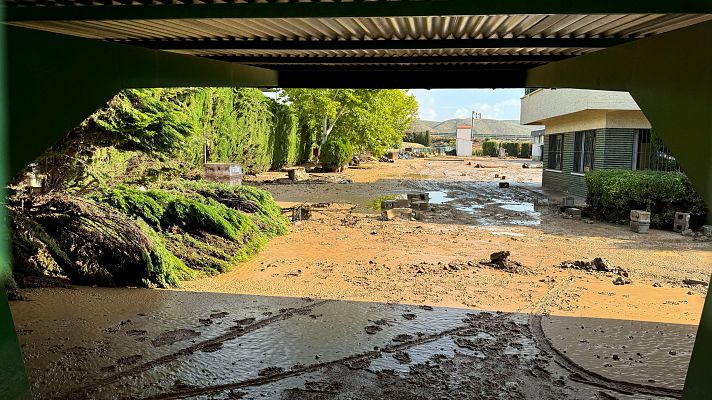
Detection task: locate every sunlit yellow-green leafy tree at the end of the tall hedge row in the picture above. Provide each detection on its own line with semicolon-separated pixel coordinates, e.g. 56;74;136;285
280;89;418;154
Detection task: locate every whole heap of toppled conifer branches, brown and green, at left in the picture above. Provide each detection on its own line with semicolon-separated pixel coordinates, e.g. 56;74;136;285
10;181;288;287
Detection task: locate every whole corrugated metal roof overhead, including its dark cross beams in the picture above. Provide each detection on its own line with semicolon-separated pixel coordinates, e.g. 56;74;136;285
5;0;712;73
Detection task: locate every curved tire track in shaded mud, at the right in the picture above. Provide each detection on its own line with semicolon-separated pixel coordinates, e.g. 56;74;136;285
529;314;682;398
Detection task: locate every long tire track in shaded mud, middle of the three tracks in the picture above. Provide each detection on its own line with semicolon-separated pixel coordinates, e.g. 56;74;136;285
138;325;484;400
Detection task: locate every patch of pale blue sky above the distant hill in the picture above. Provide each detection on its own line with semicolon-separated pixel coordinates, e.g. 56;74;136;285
410;89;524;121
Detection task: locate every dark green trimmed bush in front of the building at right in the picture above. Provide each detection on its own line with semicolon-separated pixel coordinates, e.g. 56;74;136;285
586;170;708;229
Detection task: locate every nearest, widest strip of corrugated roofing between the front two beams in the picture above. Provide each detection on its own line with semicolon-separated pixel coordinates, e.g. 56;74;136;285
12;14;712;41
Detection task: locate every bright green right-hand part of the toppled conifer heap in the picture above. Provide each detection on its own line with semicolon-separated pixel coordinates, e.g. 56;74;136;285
92;180;289;279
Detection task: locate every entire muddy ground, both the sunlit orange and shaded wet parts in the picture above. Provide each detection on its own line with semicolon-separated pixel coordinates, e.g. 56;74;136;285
11;158;712;399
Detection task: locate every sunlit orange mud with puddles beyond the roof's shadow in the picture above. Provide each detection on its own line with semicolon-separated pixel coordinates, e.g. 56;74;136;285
181;158;712;324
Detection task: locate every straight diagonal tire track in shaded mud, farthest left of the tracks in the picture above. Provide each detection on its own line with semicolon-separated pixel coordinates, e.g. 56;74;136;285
59;300;336;399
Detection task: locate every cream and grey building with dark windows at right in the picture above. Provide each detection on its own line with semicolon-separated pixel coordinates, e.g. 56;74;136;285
521;89;660;197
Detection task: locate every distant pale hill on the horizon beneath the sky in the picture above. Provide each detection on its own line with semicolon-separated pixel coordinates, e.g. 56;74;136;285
410;118;542;138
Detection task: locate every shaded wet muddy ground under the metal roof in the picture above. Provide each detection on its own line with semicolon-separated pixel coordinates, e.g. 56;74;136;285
13;288;695;399
